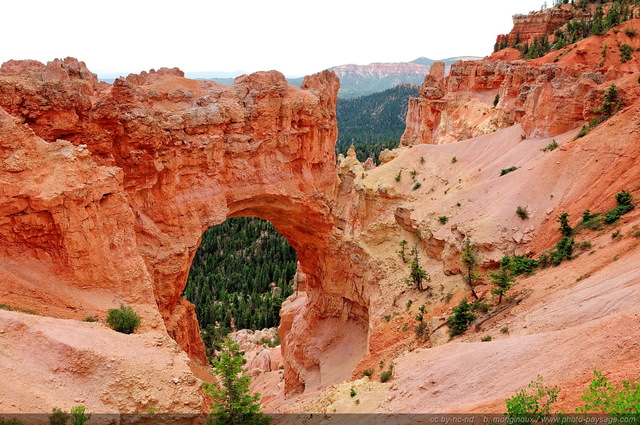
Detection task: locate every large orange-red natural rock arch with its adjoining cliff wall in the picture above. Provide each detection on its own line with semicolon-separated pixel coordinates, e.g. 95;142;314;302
0;58;370;392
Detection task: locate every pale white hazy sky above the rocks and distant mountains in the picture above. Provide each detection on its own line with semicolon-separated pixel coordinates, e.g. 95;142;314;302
0;0;551;76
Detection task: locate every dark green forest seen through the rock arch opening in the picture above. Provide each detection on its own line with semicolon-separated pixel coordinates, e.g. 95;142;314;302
182;216;297;357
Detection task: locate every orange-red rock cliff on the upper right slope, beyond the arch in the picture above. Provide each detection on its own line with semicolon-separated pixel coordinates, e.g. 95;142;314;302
401;19;640;146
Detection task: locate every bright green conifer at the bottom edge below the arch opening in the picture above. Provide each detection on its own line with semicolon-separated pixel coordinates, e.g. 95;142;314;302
202;337;271;425
